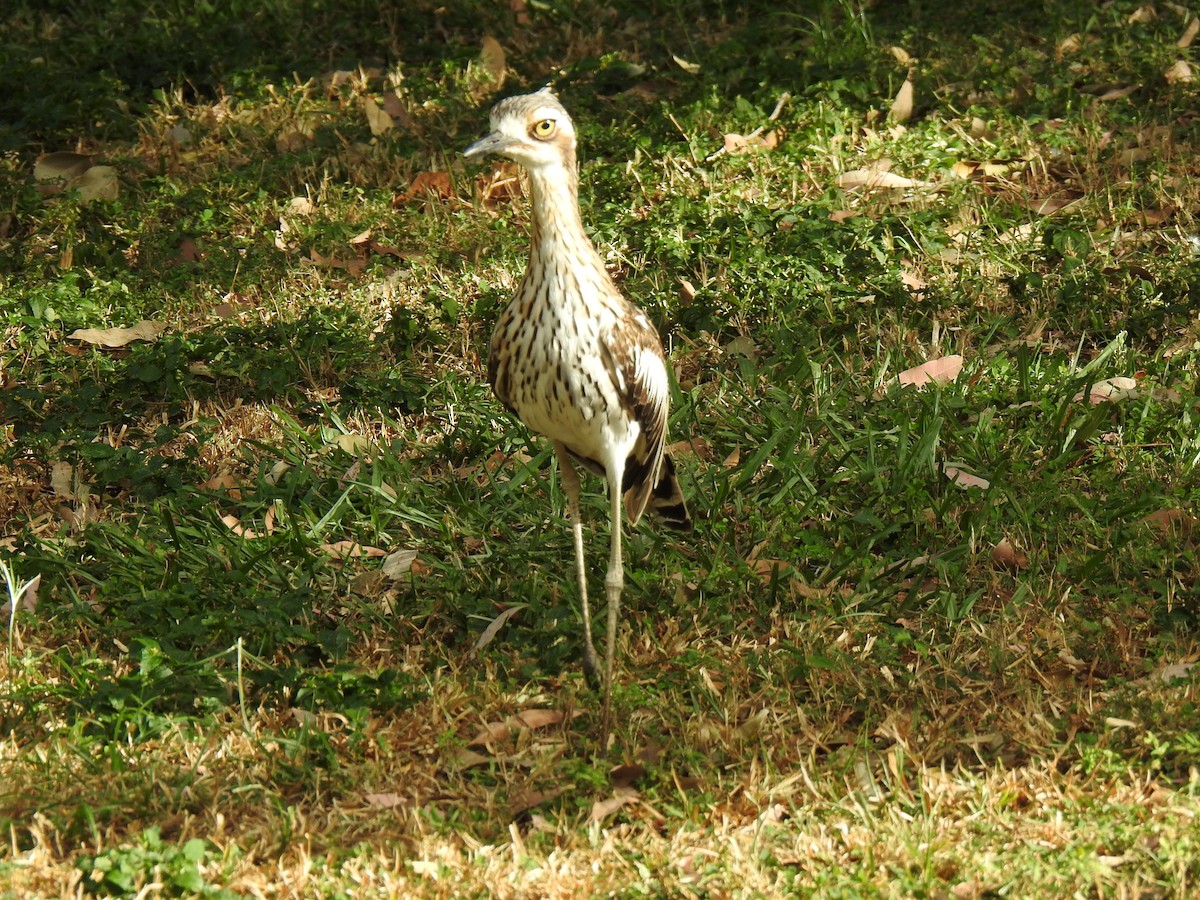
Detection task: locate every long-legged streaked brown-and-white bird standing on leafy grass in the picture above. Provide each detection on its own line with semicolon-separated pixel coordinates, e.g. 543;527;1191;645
463;86;691;748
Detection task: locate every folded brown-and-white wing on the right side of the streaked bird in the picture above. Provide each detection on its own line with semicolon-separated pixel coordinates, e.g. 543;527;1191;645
600;306;671;522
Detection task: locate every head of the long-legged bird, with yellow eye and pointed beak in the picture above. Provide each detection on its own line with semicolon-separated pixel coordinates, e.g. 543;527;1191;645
462;88;575;170
